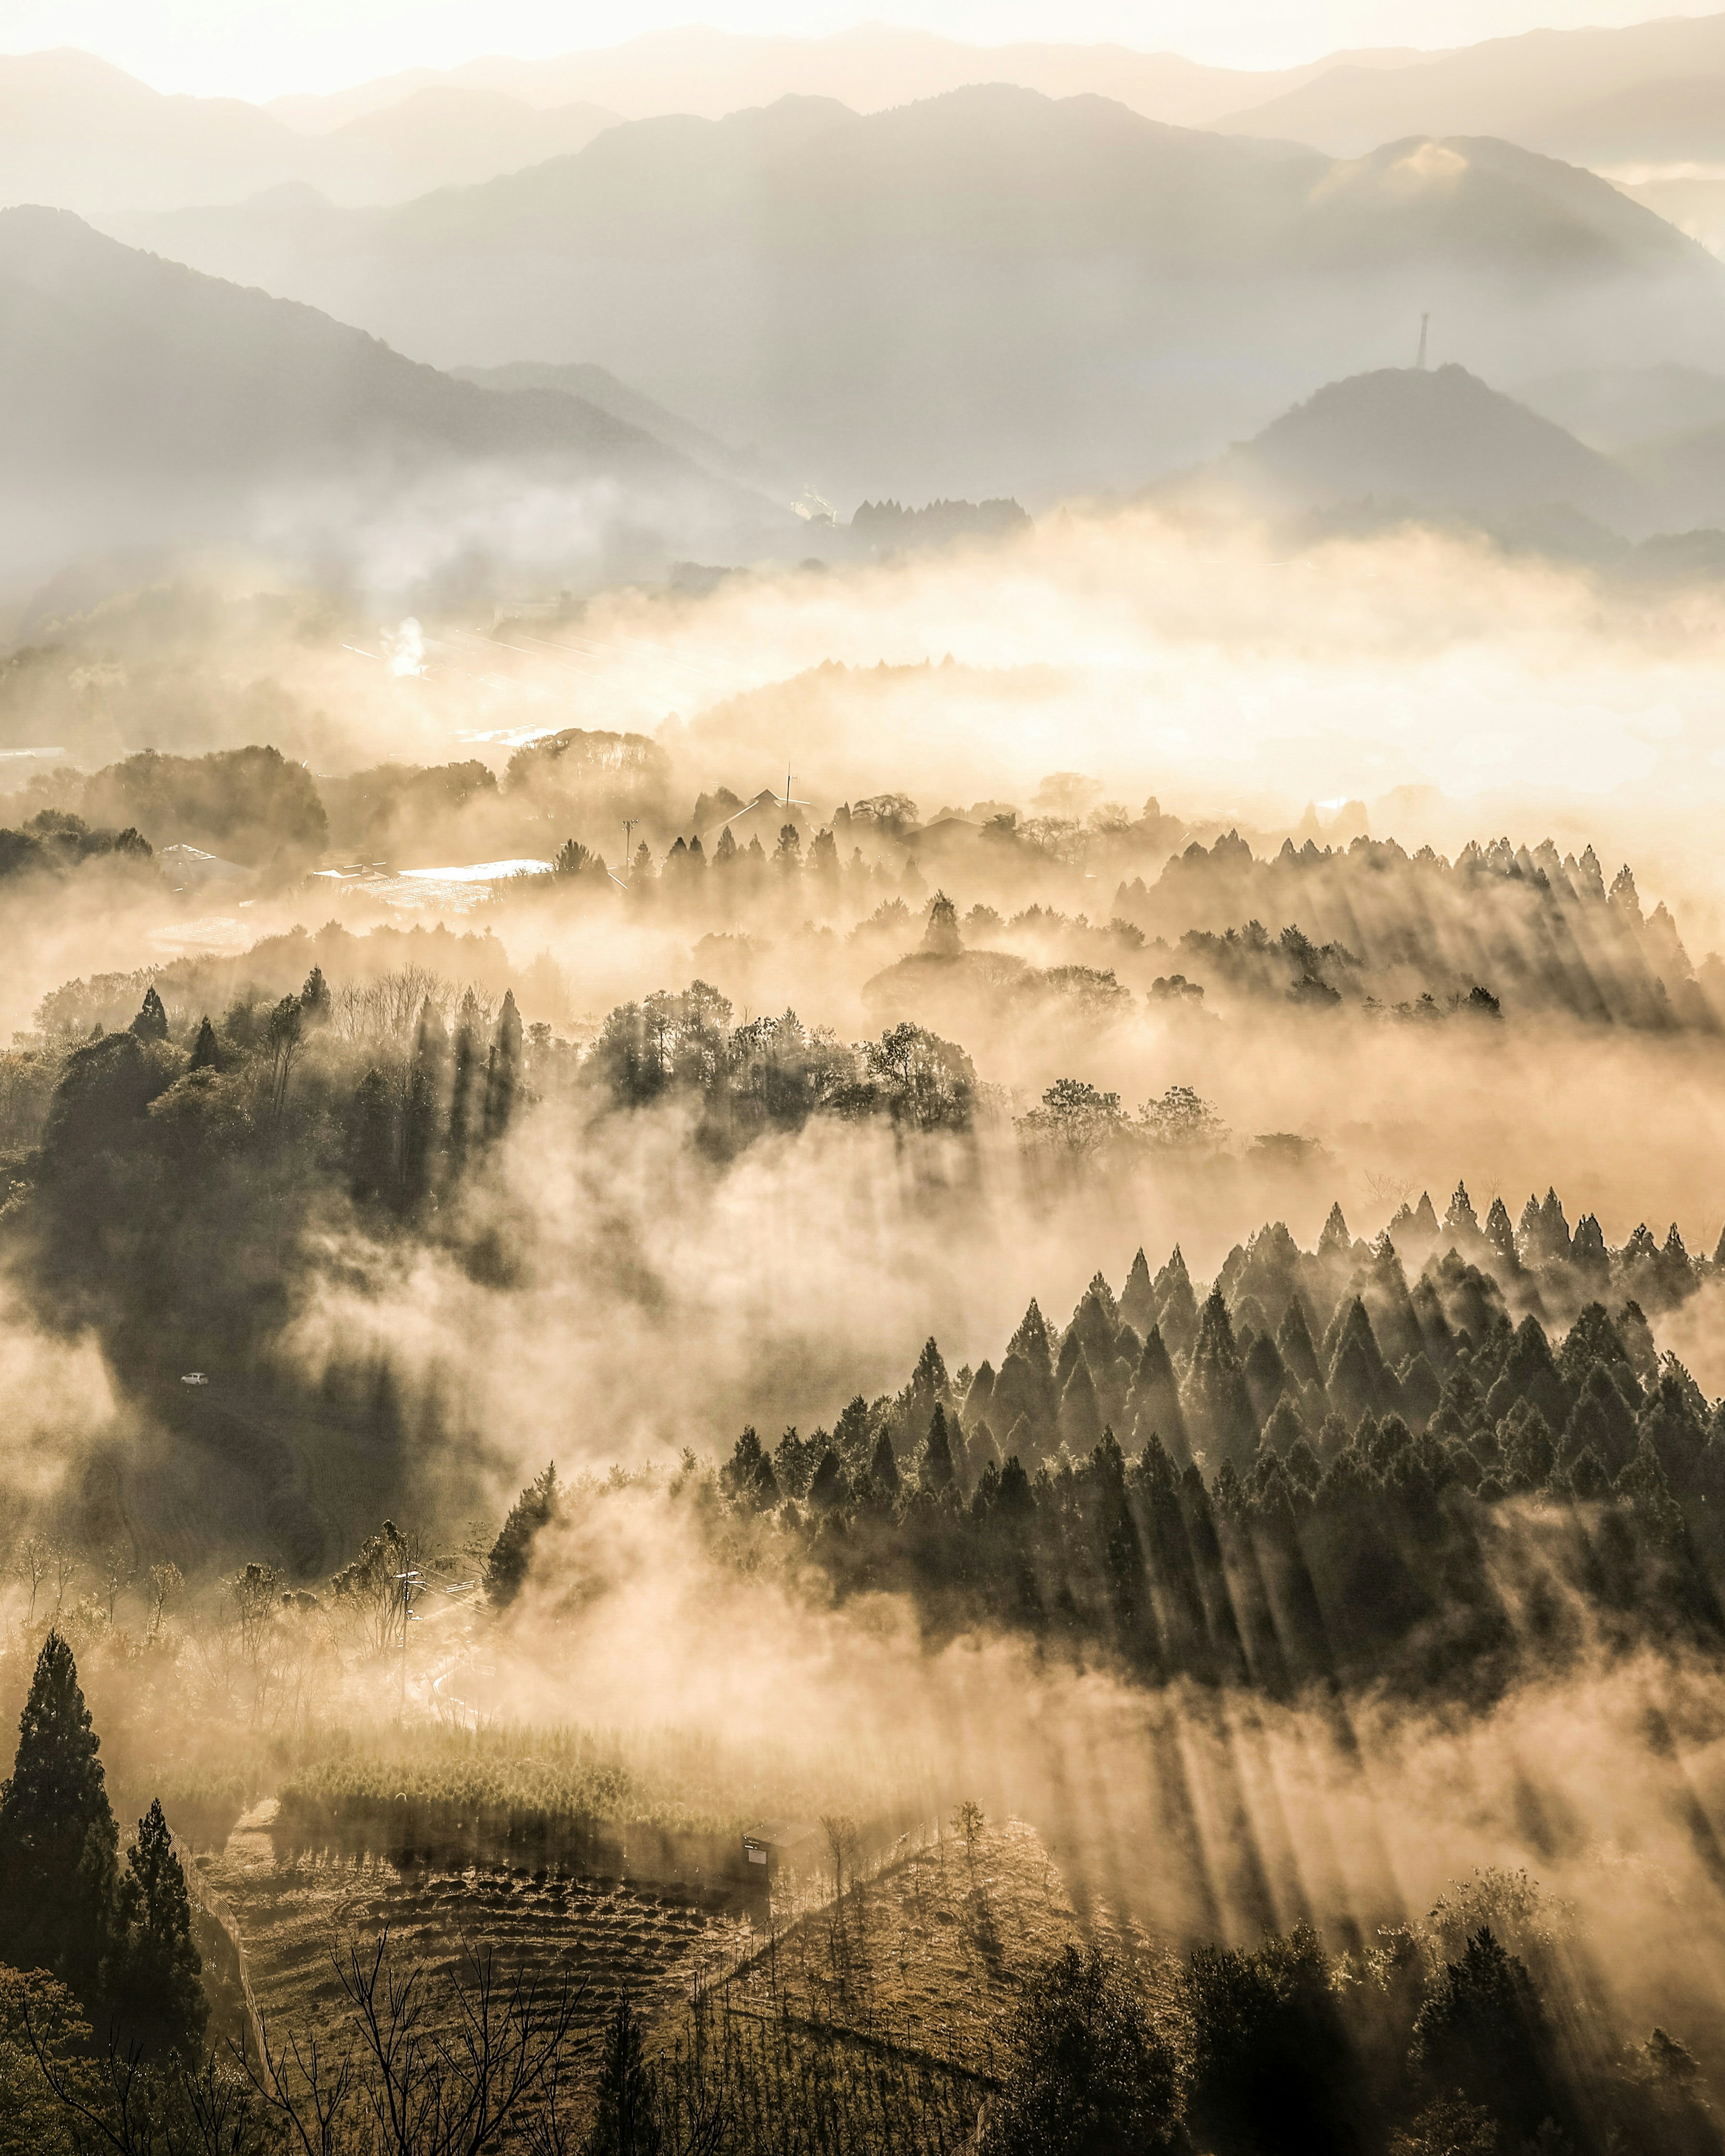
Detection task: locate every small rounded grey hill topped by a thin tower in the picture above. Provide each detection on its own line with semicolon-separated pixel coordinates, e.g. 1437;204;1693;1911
1173;364;1652;528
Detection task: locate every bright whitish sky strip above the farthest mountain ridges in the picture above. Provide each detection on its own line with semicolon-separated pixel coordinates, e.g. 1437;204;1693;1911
0;0;1721;97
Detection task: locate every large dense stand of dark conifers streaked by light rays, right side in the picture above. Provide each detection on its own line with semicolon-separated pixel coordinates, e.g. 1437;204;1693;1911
677;1216;1725;1692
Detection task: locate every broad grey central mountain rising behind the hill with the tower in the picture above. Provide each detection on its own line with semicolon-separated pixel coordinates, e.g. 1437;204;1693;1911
97;86;1725;509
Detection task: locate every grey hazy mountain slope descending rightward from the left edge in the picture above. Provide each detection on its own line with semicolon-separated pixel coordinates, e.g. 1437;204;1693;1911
0;209;792;586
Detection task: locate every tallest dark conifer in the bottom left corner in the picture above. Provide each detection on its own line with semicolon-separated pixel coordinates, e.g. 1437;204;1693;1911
0;1632;119;2016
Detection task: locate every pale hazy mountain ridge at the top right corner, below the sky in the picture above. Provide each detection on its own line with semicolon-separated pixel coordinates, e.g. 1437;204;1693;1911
1218;15;1725;164
